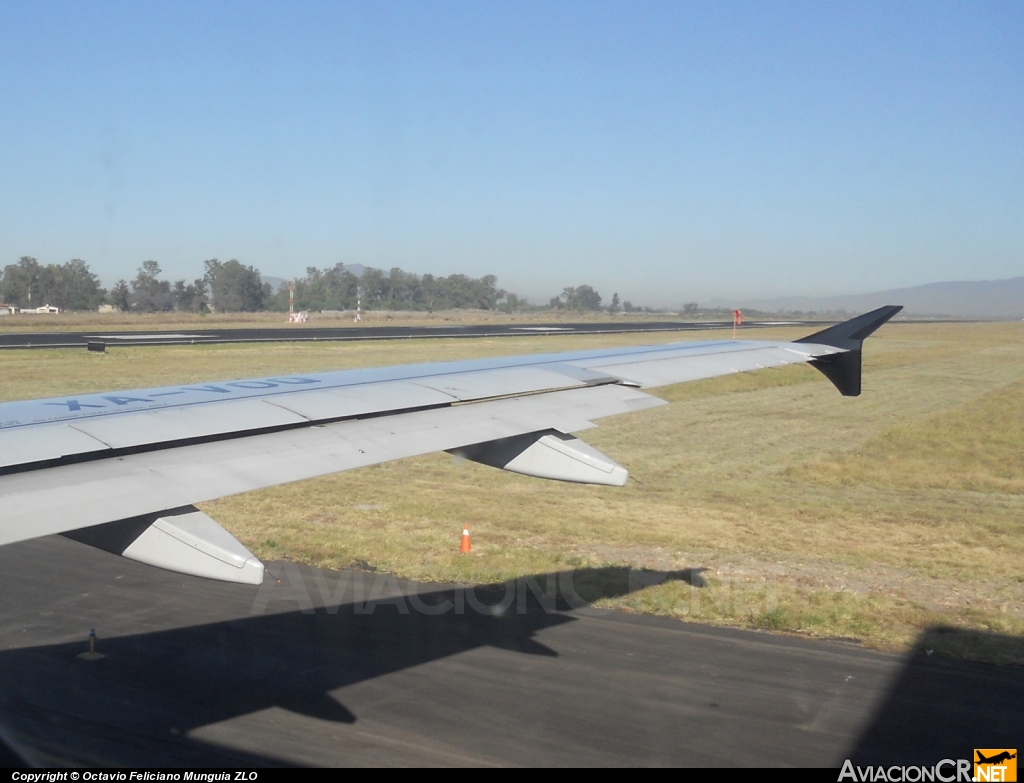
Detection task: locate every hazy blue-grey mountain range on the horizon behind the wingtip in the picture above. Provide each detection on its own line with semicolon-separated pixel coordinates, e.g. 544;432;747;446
702;277;1024;318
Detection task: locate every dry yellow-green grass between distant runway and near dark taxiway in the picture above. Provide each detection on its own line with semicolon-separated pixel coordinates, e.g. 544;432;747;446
0;323;1024;662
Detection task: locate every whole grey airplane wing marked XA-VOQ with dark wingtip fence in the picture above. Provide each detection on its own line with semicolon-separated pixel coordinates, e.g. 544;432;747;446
0;306;901;583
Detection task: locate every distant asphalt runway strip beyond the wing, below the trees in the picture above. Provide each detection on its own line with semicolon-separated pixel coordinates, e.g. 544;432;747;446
0;320;815;348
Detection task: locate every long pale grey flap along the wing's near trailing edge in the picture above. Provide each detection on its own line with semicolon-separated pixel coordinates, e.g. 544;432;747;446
0;385;665;545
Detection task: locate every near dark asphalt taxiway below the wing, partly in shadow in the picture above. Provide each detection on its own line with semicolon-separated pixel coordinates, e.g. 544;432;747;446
0;537;1024;767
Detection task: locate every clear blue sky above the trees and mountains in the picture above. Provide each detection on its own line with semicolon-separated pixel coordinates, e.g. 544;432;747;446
0;0;1024;305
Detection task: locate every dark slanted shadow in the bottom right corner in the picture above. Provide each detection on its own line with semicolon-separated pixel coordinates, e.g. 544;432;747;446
841;626;1024;774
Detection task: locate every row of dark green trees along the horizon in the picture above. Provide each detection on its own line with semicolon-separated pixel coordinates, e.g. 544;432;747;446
0;256;643;313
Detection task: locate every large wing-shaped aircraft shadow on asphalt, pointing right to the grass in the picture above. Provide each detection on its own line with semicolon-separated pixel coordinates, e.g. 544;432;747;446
0;563;700;767
